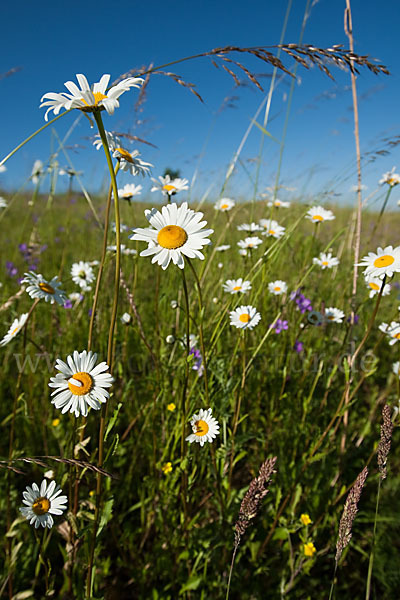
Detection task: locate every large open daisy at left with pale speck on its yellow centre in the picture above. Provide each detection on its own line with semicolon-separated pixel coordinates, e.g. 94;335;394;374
49;350;114;417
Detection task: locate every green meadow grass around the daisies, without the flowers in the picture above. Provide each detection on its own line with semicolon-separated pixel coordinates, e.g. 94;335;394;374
0;185;400;599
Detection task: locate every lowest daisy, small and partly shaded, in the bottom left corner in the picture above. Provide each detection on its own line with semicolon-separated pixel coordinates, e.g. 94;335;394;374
19;479;68;529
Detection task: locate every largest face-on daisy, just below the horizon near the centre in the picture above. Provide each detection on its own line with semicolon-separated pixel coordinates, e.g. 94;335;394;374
130;202;213;270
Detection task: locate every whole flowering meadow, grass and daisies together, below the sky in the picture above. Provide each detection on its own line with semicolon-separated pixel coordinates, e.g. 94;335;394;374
0;32;400;600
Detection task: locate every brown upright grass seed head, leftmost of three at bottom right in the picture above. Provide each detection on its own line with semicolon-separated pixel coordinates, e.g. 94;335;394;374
235;456;276;548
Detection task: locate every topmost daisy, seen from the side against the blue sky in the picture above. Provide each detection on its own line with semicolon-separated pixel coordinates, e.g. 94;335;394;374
40;74;144;121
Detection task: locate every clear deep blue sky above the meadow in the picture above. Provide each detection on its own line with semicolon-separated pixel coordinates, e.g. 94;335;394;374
0;0;400;205
